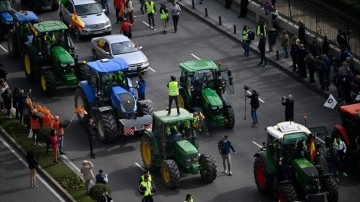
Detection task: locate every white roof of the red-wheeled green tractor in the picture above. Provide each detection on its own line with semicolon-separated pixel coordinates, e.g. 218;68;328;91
266;121;311;140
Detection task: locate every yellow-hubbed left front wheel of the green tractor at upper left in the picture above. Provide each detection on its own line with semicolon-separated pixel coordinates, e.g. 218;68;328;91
40;69;56;96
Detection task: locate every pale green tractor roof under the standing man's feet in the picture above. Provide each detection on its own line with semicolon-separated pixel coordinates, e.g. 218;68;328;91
153;108;193;124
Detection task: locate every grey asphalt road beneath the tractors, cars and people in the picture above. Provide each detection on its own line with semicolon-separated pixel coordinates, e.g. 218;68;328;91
0;1;360;202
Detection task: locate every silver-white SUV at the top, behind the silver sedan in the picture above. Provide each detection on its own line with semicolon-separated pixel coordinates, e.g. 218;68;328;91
59;0;111;38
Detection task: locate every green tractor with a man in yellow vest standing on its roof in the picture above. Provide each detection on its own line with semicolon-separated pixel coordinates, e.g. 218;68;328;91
140;108;217;188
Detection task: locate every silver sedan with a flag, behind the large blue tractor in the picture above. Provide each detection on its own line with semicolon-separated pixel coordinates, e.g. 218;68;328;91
91;34;149;73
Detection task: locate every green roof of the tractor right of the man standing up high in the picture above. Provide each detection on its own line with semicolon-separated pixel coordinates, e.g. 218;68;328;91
179;60;218;73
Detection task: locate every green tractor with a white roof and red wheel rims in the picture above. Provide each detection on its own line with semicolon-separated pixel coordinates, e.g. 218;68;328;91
254;122;339;202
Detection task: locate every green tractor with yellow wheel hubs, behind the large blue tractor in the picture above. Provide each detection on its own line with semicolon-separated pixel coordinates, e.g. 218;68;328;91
23;21;85;96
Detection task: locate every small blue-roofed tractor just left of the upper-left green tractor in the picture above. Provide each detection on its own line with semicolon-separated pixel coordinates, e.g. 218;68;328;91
7;11;39;57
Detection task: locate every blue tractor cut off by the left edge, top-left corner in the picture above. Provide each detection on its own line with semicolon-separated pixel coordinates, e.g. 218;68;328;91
0;0;13;40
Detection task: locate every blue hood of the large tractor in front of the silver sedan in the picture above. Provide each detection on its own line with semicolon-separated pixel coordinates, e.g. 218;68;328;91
111;86;136;117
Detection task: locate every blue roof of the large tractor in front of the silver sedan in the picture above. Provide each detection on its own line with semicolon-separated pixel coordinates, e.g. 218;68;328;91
87;58;129;73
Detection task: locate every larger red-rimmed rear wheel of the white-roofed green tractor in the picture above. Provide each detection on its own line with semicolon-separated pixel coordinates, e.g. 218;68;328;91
254;157;274;194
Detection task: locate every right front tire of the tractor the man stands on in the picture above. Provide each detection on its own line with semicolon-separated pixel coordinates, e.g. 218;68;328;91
199;154;217;183
